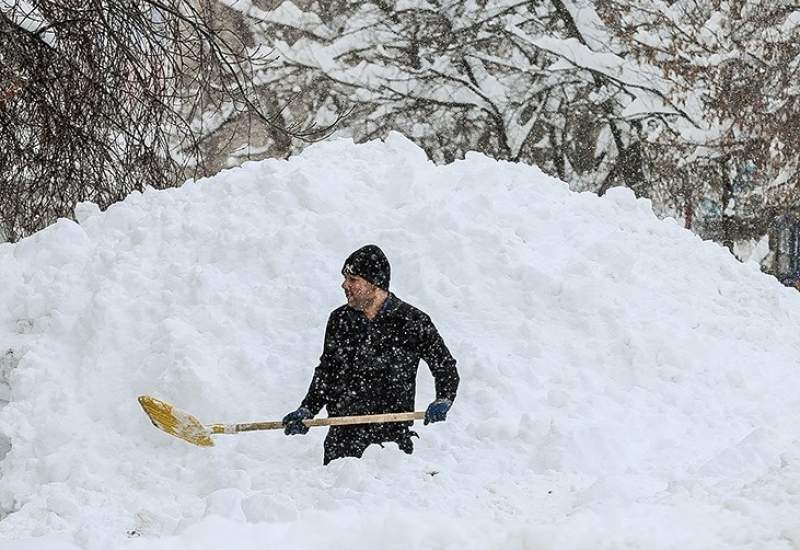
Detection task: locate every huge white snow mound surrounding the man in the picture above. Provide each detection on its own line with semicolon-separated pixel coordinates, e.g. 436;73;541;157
0;134;800;550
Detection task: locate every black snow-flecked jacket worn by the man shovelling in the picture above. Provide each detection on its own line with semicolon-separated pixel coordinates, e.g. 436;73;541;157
302;293;459;420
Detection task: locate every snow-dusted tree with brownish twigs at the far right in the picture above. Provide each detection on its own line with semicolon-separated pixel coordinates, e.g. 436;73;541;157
596;0;800;247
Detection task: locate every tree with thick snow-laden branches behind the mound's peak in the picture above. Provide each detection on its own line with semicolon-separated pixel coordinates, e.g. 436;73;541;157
226;0;653;192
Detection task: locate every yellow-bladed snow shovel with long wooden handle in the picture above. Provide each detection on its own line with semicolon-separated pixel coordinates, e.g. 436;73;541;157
139;395;425;447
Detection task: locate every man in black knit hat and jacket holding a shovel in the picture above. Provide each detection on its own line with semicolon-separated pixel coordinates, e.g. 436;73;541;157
283;245;459;464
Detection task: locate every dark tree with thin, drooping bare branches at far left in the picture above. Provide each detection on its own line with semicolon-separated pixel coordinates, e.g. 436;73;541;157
0;0;332;240
